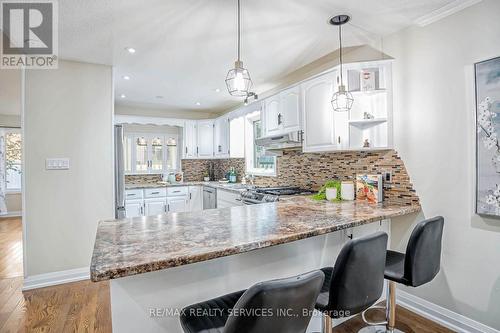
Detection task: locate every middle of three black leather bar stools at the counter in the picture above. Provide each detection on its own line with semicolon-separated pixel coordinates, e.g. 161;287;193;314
316;232;388;333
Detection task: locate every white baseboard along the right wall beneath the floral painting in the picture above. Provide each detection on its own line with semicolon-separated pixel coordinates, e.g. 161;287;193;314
396;289;500;333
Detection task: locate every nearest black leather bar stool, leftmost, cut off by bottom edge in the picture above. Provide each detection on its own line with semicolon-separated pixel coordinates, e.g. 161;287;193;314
180;271;325;333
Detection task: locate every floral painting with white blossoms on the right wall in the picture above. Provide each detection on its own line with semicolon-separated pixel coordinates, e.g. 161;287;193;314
475;57;500;217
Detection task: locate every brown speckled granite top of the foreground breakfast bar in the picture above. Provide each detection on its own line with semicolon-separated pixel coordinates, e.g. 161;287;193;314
90;196;420;281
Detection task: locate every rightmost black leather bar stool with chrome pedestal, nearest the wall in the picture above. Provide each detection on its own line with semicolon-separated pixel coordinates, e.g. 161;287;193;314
362;216;444;333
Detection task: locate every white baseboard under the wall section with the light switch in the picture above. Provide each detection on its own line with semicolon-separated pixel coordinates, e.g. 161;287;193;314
23;267;90;291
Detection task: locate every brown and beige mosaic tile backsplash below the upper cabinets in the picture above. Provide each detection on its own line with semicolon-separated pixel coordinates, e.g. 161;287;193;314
182;150;419;204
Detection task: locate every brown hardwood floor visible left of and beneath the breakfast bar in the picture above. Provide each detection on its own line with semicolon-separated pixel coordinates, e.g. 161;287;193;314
0;218;452;333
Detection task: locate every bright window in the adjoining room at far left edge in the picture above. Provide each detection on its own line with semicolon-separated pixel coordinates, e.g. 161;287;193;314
5;130;22;191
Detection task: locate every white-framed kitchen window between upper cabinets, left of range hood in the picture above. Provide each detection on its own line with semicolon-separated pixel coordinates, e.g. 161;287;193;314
245;112;276;176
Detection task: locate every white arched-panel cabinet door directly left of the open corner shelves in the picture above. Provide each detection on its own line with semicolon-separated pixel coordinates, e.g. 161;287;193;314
302;73;336;152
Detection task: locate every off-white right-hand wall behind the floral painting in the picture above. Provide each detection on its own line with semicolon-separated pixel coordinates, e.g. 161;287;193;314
384;0;500;329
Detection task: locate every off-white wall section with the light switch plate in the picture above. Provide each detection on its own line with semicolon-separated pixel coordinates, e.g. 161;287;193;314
23;60;114;277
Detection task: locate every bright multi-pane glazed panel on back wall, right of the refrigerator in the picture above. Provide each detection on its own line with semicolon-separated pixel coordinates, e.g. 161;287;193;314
124;133;179;174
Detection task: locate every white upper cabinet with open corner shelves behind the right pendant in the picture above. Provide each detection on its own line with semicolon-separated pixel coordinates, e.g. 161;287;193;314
301;60;392;152
